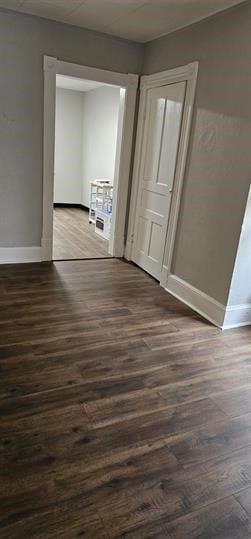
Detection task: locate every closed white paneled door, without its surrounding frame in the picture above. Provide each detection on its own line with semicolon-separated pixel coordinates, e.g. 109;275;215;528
132;82;186;280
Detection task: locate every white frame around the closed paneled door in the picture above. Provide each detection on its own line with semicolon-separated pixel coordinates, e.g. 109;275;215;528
125;62;199;287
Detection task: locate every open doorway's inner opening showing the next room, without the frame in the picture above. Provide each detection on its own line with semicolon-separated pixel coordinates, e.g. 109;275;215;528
53;75;121;260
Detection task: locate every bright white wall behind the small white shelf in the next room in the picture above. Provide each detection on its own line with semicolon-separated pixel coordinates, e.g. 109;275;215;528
83;86;120;207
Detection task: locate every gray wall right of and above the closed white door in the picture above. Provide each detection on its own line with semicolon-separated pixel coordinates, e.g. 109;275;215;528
144;2;251;304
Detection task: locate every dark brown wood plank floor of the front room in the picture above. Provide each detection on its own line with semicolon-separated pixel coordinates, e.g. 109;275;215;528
0;259;251;539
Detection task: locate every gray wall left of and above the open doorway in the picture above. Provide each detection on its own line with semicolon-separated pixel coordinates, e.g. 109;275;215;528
0;10;143;247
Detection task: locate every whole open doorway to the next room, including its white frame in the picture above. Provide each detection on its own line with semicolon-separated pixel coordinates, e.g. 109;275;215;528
41;56;139;261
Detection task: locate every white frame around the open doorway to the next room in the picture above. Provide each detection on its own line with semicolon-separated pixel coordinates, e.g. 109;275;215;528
41;56;139;261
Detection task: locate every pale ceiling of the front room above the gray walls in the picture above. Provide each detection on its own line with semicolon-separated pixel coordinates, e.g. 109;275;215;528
0;0;244;43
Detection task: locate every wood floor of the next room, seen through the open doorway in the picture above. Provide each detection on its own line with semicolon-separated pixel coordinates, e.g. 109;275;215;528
53;208;110;260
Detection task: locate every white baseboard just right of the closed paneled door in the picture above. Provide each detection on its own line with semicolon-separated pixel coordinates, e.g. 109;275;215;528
166;275;225;328
